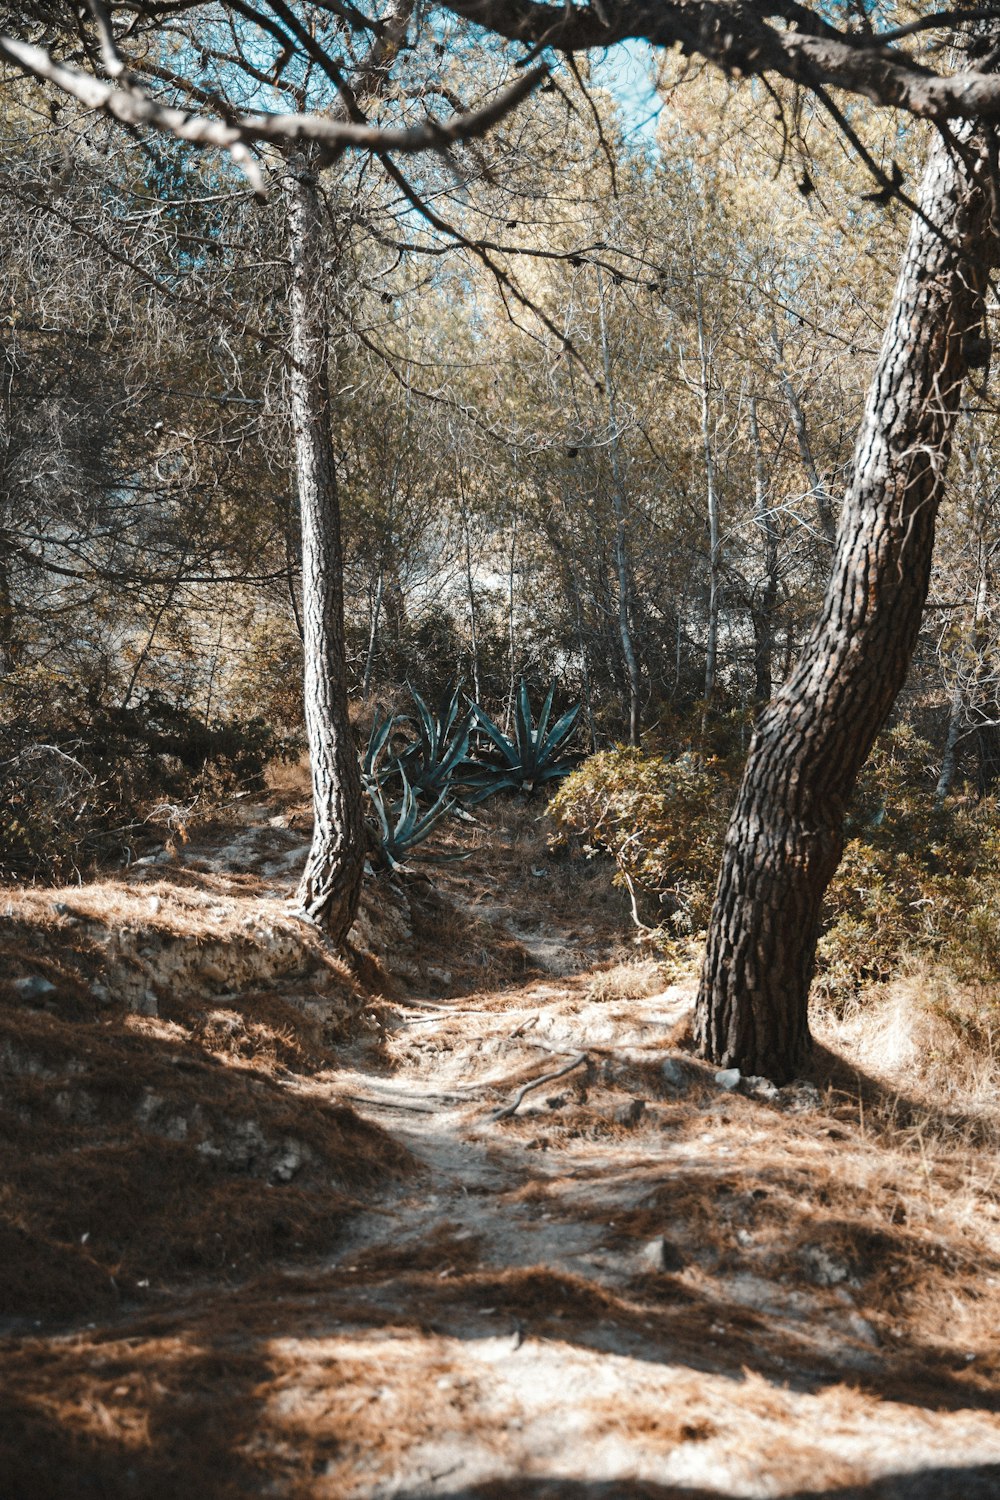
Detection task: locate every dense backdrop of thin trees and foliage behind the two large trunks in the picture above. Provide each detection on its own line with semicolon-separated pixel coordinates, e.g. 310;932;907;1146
0;11;1000;1026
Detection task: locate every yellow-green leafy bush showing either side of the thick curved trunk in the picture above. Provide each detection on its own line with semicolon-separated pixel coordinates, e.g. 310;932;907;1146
549;726;1000;1001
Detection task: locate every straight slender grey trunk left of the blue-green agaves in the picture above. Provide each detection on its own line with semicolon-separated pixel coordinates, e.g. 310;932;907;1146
283;156;364;942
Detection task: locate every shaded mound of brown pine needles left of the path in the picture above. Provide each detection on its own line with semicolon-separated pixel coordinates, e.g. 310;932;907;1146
0;984;408;1319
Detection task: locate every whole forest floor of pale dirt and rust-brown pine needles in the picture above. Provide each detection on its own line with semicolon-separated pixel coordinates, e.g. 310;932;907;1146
0;789;1000;1500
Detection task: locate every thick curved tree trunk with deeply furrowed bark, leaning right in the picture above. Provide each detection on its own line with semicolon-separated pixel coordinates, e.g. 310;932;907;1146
696;126;994;1082
